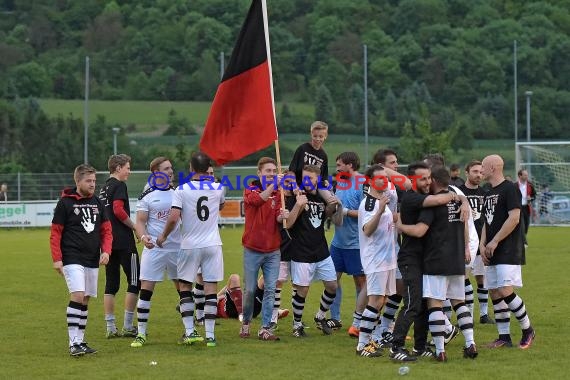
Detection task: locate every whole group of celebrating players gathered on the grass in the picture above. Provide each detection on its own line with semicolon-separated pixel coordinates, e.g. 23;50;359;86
50;121;535;362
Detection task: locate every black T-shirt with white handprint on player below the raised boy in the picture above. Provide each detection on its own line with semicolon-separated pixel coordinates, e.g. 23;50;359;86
285;194;329;263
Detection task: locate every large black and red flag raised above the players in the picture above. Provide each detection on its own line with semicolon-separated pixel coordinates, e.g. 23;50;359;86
200;0;277;165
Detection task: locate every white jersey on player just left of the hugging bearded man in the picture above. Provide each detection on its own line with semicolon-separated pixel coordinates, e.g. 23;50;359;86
358;196;398;274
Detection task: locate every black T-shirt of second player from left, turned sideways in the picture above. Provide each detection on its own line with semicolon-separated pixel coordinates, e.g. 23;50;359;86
99;177;136;251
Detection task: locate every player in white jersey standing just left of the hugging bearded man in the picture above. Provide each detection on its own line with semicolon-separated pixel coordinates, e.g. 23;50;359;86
356;164;397;357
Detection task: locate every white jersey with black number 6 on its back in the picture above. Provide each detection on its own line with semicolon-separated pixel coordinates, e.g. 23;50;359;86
172;180;225;249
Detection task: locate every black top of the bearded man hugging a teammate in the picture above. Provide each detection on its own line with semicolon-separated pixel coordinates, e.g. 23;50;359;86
398;190;428;265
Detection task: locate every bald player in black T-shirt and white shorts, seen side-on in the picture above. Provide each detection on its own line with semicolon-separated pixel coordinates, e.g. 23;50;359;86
479;154;535;349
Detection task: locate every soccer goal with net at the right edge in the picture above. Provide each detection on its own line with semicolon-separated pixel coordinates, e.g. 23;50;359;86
515;141;570;226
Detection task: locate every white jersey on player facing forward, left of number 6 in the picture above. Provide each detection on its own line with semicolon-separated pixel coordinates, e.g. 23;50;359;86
137;188;182;251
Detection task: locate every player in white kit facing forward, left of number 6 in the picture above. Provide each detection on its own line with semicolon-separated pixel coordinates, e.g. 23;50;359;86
131;156;180;347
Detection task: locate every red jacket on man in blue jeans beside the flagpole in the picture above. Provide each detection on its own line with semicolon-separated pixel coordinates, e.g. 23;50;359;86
241;187;281;253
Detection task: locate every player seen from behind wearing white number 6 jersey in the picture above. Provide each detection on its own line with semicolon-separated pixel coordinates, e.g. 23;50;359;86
157;152;225;347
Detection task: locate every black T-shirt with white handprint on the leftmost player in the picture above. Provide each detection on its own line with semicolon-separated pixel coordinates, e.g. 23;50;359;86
52;189;110;268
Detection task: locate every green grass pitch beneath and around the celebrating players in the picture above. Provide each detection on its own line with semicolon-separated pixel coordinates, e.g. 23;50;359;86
4;227;570;379
